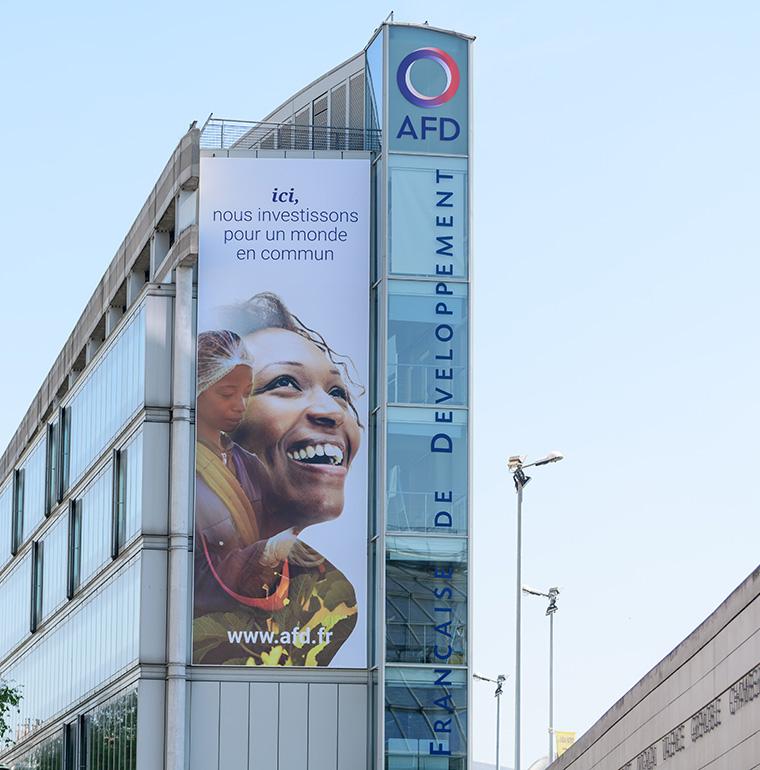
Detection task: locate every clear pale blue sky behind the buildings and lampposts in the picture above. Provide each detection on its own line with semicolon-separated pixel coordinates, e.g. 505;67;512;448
0;0;760;767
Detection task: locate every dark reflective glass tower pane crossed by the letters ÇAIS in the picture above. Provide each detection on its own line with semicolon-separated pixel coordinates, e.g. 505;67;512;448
385;536;467;666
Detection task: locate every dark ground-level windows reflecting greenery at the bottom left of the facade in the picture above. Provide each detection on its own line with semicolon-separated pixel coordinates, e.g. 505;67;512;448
11;689;137;770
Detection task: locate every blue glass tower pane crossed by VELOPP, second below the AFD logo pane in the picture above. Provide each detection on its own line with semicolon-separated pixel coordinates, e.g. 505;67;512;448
387;281;467;407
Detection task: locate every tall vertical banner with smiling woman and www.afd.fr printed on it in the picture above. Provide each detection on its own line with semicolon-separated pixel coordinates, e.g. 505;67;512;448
193;158;369;668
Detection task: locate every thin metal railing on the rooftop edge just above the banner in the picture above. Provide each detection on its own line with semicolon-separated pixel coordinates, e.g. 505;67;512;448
201;117;380;152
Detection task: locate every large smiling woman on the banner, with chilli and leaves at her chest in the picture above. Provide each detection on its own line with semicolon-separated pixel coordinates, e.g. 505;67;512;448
193;293;361;666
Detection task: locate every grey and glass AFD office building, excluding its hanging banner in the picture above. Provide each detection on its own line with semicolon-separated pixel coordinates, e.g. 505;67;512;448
0;22;472;770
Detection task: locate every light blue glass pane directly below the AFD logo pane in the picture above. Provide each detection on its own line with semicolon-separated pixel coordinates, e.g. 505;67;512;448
388;155;468;280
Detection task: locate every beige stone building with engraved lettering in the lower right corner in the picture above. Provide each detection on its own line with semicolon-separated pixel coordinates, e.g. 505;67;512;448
550;568;760;770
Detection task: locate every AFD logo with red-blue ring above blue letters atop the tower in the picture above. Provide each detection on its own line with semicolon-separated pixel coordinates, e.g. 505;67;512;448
396;48;461;142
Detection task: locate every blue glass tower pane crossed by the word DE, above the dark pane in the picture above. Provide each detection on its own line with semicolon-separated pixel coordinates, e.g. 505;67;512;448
386;405;467;535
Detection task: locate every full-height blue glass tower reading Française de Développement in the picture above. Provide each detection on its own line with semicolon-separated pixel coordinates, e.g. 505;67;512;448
380;24;470;770
